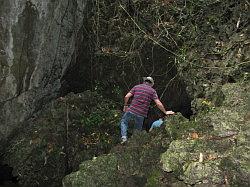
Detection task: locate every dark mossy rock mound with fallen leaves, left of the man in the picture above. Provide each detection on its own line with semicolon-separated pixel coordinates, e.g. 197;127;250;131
3;91;120;186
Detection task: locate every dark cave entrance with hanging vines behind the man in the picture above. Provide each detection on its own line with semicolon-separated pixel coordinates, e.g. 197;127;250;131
60;32;193;119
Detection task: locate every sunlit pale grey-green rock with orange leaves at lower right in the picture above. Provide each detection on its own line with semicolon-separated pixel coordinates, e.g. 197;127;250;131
161;83;250;186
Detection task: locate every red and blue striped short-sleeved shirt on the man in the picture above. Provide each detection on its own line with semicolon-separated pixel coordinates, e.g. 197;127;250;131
127;83;158;117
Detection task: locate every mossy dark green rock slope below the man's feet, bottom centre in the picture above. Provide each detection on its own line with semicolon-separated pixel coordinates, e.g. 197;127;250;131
63;129;176;187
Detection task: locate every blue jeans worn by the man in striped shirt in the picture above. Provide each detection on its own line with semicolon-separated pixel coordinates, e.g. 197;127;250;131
120;112;144;137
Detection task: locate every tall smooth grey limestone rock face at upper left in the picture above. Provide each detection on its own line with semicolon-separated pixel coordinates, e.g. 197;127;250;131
0;0;86;145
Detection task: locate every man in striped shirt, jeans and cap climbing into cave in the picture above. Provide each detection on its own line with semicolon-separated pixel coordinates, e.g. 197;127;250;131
120;77;174;143
